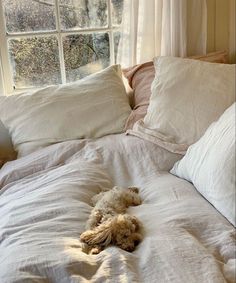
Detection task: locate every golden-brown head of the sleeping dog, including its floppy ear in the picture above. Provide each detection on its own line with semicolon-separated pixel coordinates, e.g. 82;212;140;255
80;214;142;252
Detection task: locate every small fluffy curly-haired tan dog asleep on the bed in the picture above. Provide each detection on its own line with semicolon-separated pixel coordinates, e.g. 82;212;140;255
80;187;142;254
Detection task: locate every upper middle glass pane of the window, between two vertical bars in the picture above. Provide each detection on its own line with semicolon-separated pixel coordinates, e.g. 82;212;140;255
59;0;107;29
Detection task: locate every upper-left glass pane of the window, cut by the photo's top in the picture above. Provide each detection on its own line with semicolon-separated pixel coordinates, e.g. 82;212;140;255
2;0;56;33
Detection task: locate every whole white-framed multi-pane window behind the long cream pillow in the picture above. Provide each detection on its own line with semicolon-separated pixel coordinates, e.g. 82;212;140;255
0;0;123;93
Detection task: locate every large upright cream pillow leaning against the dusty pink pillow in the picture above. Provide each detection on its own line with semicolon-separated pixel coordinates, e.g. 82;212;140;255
128;57;235;154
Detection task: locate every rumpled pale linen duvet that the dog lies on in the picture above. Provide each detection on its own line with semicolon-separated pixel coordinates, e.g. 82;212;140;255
0;134;235;283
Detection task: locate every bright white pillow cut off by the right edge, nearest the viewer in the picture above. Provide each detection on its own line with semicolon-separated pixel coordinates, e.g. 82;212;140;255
170;103;236;226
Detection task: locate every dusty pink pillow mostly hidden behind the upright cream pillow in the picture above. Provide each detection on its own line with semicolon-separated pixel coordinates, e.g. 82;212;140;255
123;51;228;129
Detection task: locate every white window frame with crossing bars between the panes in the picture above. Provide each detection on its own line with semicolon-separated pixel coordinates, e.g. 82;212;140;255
0;0;119;95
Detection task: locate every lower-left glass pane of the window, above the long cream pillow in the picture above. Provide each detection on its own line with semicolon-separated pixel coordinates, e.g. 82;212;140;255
8;36;61;88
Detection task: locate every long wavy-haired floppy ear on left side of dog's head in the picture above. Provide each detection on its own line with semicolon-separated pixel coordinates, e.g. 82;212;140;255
80;220;112;247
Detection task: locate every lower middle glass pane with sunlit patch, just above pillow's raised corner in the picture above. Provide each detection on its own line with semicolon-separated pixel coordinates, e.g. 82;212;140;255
63;33;110;82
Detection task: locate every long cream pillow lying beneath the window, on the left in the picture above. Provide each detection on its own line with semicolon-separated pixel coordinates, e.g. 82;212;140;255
0;65;131;156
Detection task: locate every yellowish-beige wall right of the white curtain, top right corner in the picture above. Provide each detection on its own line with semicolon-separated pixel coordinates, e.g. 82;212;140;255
207;0;236;63
